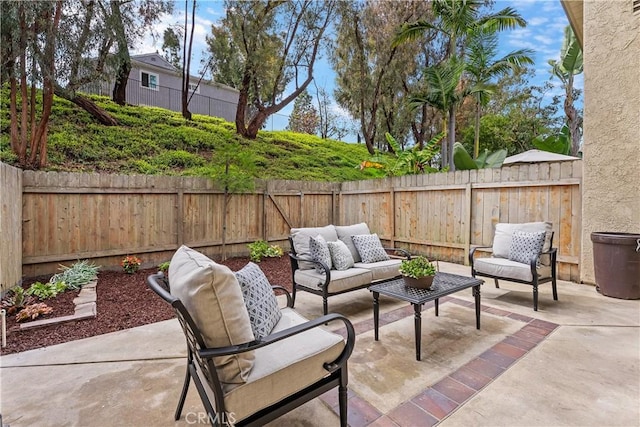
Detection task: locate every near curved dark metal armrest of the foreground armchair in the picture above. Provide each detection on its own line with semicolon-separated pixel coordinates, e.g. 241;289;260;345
198;313;356;372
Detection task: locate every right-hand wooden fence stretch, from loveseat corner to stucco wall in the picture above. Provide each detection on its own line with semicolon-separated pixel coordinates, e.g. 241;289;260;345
340;161;582;281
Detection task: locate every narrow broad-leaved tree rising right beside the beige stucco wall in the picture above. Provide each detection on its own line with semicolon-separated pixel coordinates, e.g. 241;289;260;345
549;25;583;156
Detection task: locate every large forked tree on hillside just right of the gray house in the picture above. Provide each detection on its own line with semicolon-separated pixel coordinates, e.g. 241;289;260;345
207;0;336;139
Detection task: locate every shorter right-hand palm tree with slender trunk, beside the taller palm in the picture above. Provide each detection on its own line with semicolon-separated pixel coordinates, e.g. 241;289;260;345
465;31;534;159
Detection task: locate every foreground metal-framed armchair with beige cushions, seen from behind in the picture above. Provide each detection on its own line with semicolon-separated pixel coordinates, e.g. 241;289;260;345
147;246;355;426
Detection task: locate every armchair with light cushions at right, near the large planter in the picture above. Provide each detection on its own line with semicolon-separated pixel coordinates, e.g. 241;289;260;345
469;222;558;311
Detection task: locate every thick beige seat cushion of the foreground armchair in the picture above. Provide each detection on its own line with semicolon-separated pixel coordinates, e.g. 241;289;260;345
212;308;345;421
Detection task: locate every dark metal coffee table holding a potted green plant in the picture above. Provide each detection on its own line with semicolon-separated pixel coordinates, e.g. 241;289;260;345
369;273;484;360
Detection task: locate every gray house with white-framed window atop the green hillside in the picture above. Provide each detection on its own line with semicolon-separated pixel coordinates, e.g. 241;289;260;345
86;53;238;121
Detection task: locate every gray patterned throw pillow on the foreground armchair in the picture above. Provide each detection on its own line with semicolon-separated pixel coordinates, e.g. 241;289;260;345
234;262;282;340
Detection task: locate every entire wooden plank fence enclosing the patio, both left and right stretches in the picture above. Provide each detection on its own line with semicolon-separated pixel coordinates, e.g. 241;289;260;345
2;161;582;290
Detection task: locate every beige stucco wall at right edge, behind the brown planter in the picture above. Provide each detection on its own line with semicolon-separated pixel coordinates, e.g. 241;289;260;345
580;0;640;283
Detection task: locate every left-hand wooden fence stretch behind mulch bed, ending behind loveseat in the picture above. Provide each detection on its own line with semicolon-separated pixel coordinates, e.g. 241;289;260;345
22;171;339;276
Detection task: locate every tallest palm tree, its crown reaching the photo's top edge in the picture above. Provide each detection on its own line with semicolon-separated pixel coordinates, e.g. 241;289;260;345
394;0;526;169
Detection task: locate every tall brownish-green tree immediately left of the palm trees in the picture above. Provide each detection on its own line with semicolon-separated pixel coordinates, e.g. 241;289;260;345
330;0;430;154
